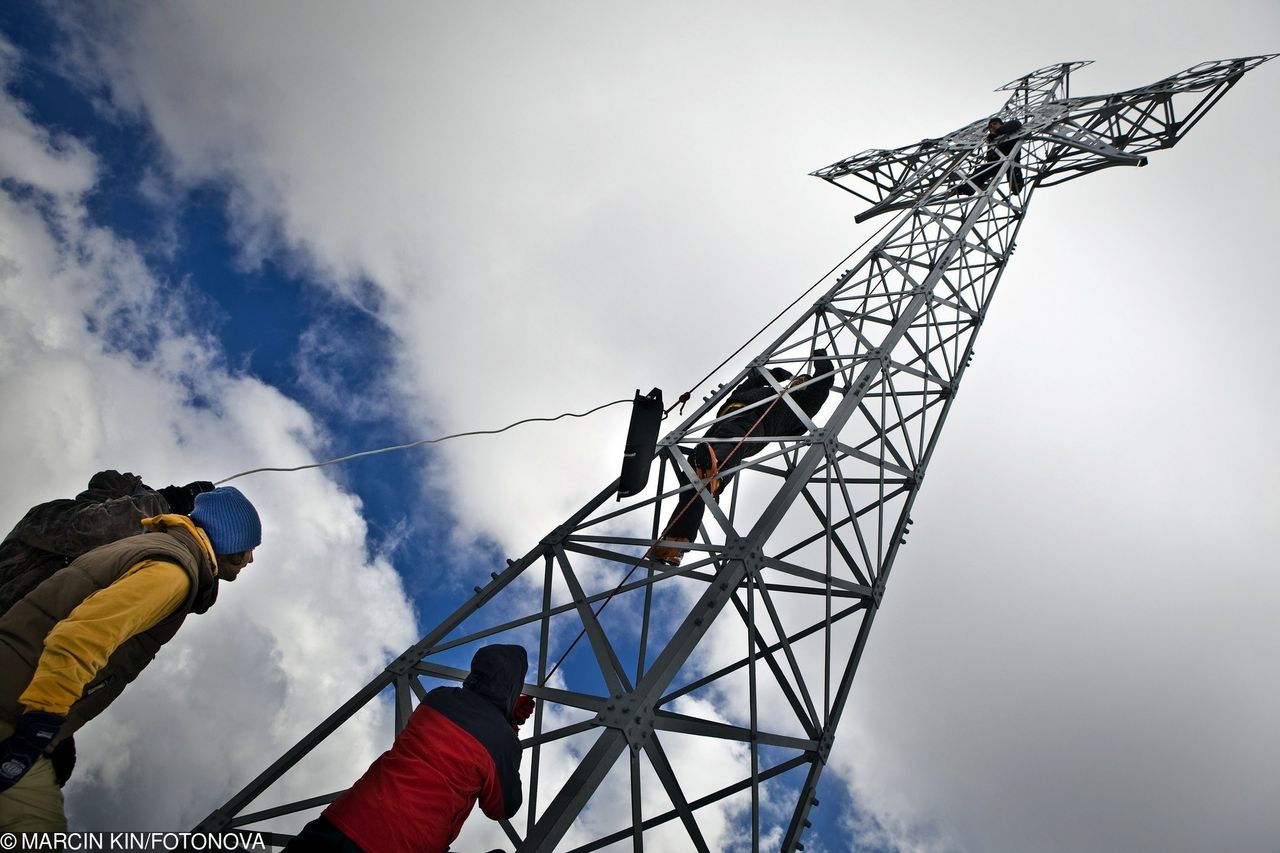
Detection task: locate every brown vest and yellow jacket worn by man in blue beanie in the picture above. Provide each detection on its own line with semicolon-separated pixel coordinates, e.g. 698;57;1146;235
0;515;218;743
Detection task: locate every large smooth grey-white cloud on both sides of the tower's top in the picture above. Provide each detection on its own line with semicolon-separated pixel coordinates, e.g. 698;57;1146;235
22;3;1280;850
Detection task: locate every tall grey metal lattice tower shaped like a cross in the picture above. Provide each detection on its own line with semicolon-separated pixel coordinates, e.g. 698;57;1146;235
198;55;1274;853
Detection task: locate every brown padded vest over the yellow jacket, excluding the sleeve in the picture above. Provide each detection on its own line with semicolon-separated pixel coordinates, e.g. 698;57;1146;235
0;516;218;743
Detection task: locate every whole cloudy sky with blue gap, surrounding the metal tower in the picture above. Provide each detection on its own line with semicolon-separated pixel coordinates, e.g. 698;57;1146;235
0;0;1280;853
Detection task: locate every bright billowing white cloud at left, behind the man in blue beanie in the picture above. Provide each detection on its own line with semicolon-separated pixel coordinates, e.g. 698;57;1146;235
0;43;415;829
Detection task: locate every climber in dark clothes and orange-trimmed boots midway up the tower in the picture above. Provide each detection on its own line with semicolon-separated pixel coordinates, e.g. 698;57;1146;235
650;350;836;566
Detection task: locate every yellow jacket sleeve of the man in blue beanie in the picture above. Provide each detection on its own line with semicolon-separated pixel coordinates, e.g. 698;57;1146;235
18;560;191;716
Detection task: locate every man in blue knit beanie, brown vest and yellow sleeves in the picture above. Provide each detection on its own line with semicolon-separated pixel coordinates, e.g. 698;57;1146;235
0;487;262;833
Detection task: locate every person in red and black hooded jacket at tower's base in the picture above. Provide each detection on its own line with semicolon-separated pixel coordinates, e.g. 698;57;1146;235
284;644;534;853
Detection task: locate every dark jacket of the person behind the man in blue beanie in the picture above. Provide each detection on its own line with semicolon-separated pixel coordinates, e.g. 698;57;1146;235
0;471;169;613
